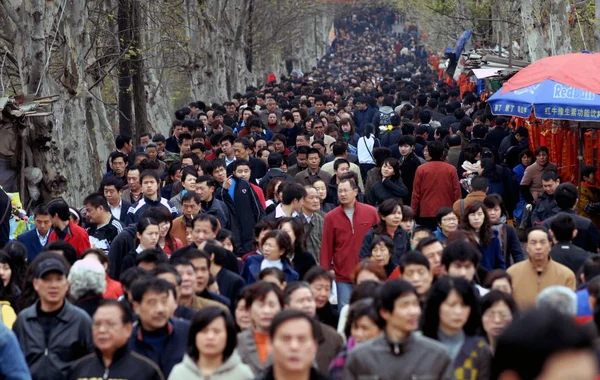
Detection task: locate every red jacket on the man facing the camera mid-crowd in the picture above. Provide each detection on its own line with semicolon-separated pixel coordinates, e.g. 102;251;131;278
320;202;379;282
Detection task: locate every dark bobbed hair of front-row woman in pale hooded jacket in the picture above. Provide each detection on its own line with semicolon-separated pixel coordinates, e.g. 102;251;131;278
187;306;237;362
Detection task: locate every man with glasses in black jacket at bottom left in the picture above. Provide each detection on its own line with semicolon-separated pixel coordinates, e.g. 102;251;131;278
69;299;164;380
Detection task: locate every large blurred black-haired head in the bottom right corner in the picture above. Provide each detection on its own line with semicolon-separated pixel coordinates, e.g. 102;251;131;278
491;309;598;380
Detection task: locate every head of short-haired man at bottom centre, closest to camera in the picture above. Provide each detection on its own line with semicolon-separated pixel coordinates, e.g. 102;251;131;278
269;309;320;374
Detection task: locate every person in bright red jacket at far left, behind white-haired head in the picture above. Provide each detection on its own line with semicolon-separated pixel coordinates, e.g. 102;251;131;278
48;199;91;258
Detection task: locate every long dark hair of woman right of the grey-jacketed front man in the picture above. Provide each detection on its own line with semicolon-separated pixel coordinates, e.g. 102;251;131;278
423;277;481;340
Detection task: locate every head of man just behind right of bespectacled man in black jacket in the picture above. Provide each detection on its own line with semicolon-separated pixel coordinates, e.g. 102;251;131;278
131;277;175;331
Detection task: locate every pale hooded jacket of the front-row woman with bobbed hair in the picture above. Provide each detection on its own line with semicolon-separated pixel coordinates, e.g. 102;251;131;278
169;351;254;380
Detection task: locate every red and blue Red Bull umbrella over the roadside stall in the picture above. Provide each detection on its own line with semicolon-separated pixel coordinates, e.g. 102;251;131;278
488;52;600;121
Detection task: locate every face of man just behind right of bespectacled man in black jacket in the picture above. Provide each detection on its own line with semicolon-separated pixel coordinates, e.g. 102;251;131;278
133;291;172;331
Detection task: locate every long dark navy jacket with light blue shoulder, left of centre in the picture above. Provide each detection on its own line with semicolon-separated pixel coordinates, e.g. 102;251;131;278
216;179;265;256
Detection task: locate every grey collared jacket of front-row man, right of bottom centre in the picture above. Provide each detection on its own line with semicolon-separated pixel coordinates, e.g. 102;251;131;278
343;333;454;380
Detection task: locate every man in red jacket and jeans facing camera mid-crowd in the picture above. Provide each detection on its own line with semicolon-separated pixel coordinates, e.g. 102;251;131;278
321;179;379;309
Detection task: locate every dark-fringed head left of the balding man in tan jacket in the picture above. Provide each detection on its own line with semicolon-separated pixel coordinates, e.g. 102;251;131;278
442;240;481;282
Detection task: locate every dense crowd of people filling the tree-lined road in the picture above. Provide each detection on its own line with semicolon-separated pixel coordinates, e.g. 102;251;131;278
0;5;600;380
